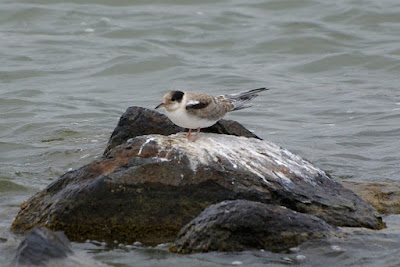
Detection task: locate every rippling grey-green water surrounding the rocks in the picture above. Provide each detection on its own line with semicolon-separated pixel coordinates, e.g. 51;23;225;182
0;0;400;266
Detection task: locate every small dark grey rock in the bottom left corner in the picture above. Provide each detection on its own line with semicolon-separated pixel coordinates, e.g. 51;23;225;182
12;227;73;266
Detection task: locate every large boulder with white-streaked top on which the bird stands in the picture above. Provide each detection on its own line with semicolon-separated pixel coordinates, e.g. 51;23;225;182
12;133;384;244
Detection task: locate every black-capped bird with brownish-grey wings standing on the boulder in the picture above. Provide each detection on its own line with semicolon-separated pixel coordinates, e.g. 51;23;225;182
155;88;269;142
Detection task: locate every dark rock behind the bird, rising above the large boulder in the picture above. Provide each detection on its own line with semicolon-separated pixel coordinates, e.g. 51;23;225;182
104;107;260;153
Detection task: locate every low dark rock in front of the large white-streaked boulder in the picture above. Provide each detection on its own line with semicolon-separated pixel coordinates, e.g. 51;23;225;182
170;200;335;253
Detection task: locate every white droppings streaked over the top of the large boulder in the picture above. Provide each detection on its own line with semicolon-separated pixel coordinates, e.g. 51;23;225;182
139;133;326;187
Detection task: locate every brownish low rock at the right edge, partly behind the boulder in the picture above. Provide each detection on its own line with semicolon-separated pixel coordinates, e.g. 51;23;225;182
341;181;400;214
